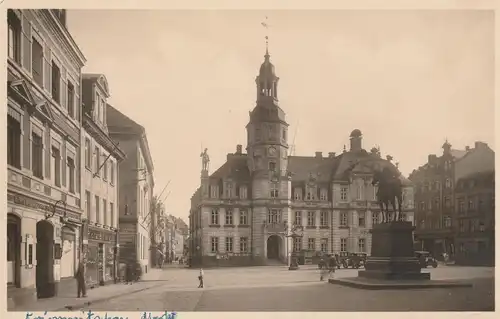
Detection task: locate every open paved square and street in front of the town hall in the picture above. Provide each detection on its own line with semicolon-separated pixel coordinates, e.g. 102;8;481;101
69;266;494;312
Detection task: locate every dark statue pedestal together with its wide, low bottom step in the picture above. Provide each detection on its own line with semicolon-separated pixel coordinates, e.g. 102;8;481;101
329;221;470;289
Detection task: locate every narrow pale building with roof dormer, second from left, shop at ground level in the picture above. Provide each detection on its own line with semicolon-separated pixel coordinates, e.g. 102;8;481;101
80;74;125;286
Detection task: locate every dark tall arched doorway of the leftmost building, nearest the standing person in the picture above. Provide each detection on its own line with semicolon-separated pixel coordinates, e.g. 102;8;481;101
36;220;55;298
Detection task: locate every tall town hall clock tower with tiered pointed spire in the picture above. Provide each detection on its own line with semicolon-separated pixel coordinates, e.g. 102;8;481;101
246;48;291;262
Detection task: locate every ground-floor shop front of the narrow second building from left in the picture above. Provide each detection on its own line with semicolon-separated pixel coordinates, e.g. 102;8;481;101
86;226;117;287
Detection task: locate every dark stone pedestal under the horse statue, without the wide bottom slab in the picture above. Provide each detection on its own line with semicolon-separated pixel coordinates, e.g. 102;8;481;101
358;221;430;280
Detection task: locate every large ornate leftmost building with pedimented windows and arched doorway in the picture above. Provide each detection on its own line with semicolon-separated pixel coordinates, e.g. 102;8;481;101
7;9;85;304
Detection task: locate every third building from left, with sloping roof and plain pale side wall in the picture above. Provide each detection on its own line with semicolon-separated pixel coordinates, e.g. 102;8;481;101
107;104;154;272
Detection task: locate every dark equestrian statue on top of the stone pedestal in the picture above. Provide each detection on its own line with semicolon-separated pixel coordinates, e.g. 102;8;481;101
372;167;403;223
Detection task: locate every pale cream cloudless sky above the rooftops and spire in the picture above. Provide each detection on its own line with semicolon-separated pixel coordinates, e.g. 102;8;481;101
68;10;494;222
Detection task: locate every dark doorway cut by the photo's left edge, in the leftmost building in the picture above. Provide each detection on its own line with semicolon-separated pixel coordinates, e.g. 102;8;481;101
7;214;21;287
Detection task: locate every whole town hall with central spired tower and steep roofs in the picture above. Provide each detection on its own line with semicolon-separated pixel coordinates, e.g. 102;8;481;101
189;48;413;266
